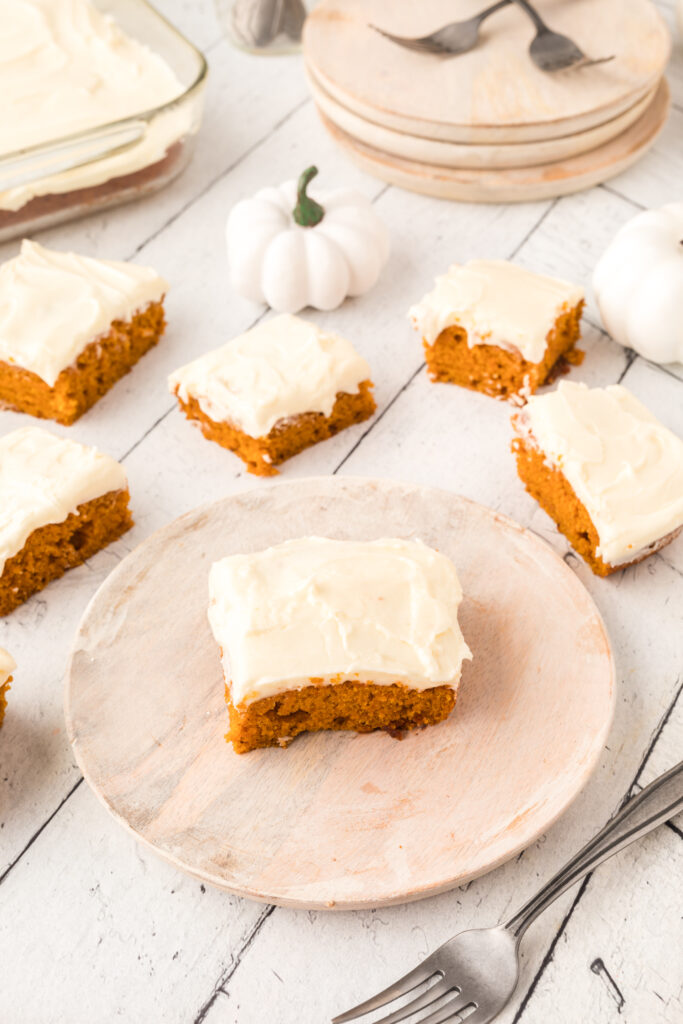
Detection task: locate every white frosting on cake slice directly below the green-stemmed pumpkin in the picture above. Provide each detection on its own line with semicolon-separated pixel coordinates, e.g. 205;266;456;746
169;313;370;437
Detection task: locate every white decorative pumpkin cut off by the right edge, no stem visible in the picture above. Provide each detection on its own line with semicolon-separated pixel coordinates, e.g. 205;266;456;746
593;203;683;362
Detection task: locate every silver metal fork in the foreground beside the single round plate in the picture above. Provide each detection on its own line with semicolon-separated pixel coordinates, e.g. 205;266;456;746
332;761;683;1024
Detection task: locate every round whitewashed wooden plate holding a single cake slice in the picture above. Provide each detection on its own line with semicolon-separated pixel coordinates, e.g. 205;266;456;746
66;477;614;908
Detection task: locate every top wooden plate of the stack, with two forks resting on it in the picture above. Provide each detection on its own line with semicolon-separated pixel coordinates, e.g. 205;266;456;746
304;0;671;143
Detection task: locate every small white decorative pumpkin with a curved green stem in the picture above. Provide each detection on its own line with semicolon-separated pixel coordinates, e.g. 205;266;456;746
226;167;389;313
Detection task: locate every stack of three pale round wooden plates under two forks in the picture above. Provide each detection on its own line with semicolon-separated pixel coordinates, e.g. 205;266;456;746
304;0;671;202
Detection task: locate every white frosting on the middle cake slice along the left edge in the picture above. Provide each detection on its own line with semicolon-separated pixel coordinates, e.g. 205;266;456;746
0;427;127;572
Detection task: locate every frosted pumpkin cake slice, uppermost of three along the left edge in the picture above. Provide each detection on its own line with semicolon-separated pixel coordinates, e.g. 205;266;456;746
0;241;167;424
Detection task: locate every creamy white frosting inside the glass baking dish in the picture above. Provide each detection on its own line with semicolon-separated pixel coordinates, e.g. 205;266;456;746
0;0;197;210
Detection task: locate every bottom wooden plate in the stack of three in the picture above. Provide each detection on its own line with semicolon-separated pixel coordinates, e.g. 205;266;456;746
318;79;670;203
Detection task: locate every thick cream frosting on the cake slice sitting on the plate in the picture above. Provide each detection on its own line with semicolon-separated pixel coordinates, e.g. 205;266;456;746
208;537;472;706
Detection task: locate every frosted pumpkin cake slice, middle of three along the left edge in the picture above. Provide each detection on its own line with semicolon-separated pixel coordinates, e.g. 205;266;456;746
0;427;133;615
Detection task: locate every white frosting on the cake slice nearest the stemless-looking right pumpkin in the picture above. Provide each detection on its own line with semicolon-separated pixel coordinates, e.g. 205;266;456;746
409;259;584;362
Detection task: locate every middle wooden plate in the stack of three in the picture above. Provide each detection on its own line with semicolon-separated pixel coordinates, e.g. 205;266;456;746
306;70;656;170
